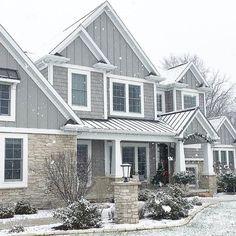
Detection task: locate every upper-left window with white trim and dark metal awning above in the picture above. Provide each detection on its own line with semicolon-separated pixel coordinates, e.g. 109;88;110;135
0;68;20;121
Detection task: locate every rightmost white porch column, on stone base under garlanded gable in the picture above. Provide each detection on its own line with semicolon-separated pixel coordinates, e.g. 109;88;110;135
203;143;215;175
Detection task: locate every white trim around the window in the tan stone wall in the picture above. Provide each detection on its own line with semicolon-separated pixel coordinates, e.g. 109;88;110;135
0;134;28;189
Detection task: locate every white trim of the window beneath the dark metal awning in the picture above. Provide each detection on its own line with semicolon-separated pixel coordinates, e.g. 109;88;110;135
0;81;16;121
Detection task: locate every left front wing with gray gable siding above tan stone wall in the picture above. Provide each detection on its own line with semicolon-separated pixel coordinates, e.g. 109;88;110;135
0;25;81;207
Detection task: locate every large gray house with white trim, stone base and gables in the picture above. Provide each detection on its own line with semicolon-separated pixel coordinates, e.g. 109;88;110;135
0;2;235;206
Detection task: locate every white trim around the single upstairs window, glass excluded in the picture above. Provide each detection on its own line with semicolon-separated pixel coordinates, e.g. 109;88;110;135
68;69;91;111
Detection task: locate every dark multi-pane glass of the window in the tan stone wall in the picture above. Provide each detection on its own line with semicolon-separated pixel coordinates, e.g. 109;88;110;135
5;138;23;181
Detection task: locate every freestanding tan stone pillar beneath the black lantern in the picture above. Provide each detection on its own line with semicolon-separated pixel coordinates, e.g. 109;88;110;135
112;181;141;224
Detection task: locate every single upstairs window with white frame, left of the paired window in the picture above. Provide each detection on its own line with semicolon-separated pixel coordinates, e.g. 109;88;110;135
68;70;91;111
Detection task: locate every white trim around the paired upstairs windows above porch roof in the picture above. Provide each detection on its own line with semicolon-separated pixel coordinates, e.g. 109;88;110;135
110;78;144;117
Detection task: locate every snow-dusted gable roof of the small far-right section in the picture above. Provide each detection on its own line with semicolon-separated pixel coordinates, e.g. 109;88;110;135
209;116;236;139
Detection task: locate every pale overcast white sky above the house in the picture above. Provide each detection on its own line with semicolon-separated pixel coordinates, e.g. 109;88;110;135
0;0;236;82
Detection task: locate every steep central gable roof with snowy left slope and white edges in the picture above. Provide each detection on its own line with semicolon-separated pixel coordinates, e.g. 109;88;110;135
34;1;160;75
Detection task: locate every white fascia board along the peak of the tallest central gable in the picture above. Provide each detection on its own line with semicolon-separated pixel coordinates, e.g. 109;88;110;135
81;1;160;76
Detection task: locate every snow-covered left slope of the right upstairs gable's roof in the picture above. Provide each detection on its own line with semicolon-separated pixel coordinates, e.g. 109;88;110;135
161;62;190;84
